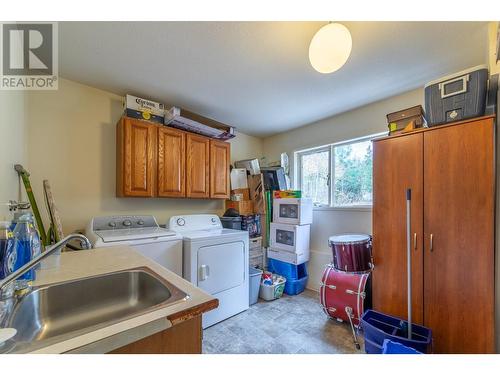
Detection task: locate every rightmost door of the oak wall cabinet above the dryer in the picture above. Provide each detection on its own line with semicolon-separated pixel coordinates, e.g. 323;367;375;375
210;140;230;199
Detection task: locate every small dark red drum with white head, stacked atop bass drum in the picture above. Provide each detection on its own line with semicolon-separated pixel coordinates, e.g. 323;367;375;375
328;234;373;272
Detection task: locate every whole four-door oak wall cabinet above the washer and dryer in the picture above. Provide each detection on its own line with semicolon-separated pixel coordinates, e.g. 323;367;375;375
116;117;231;199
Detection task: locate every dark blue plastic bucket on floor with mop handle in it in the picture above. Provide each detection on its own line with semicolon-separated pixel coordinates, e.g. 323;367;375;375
361;310;432;354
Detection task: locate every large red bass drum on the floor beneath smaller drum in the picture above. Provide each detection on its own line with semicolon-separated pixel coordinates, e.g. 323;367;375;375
319;264;371;327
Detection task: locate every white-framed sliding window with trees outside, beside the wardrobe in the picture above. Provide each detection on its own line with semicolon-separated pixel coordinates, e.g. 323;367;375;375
295;134;381;207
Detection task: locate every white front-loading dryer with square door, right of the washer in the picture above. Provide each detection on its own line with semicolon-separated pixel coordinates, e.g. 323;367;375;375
168;215;249;328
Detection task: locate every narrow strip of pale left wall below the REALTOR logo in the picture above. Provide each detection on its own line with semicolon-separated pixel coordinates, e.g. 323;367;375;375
0;91;26;220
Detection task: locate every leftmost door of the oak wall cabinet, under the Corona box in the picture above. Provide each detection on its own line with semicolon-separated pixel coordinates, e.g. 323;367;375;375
116;117;156;197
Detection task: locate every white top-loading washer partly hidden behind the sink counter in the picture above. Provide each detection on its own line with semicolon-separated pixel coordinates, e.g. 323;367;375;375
85;215;182;277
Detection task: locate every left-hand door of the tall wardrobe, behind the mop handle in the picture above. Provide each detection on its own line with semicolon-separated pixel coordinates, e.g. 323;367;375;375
372;134;423;323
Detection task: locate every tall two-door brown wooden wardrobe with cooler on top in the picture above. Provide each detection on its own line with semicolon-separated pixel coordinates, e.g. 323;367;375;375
373;116;495;353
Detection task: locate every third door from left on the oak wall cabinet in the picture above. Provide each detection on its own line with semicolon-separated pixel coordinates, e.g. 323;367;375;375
186;134;210;198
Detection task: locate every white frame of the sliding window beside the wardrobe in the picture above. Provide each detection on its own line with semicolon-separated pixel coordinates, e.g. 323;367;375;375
294;132;387;211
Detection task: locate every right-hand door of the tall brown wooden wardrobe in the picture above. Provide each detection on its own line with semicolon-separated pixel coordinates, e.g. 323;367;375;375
424;119;494;353
